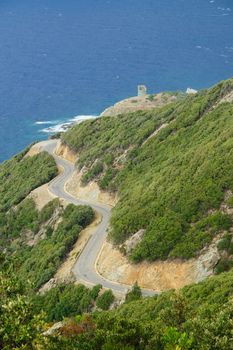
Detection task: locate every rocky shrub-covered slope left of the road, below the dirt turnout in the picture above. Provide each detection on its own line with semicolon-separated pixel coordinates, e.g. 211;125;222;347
0;199;94;290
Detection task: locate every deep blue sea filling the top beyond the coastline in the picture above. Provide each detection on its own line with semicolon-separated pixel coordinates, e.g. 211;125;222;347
0;0;233;161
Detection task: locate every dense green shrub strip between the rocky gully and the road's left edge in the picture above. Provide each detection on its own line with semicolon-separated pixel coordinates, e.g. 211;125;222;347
12;204;94;289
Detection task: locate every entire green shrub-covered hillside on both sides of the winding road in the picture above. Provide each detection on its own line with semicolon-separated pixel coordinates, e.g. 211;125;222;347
0;80;233;350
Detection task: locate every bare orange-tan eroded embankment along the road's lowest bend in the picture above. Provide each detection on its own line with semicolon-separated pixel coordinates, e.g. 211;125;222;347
97;242;219;291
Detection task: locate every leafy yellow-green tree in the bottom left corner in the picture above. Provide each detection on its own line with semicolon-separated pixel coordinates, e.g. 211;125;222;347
0;264;44;350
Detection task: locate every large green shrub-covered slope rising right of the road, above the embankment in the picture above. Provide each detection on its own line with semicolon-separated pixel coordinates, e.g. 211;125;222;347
63;80;233;262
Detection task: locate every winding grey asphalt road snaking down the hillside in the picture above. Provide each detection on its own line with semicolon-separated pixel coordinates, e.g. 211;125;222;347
42;140;158;296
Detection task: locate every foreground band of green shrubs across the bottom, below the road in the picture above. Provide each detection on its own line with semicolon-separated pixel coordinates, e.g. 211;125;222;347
0;253;233;350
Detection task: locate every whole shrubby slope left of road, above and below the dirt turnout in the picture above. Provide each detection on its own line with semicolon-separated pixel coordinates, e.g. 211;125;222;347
0;146;94;289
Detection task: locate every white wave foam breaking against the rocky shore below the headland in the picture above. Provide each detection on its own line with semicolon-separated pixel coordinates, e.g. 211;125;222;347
39;115;98;134
